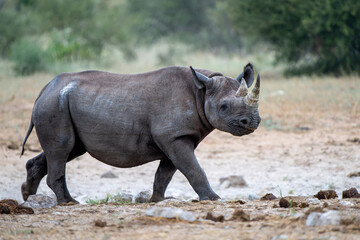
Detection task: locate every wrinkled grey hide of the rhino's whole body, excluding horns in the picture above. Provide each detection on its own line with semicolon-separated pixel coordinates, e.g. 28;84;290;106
21;65;260;204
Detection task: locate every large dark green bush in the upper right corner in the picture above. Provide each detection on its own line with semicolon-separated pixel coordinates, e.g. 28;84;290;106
228;0;360;75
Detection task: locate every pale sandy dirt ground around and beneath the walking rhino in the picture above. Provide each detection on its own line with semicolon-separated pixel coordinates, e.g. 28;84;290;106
0;74;360;239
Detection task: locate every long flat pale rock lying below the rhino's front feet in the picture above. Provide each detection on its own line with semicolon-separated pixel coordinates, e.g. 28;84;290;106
145;207;196;222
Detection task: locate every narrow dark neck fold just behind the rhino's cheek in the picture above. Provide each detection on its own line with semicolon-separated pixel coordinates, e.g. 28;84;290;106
195;90;215;141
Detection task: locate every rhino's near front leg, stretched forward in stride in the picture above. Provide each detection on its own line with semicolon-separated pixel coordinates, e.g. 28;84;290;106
160;137;220;201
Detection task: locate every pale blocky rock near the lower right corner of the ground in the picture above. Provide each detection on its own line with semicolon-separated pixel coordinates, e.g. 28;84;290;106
306;210;340;227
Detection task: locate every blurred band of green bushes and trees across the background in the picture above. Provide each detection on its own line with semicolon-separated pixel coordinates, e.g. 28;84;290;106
0;0;360;75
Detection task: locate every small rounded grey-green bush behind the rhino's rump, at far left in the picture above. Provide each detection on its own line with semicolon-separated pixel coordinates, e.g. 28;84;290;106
10;39;46;75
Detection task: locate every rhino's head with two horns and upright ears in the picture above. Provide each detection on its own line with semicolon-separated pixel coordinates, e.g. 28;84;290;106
190;63;261;136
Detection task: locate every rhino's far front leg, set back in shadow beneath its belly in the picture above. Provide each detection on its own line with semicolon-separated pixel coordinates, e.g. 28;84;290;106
150;158;176;202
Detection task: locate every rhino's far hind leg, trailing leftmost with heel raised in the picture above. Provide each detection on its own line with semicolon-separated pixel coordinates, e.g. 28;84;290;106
21;152;47;201
